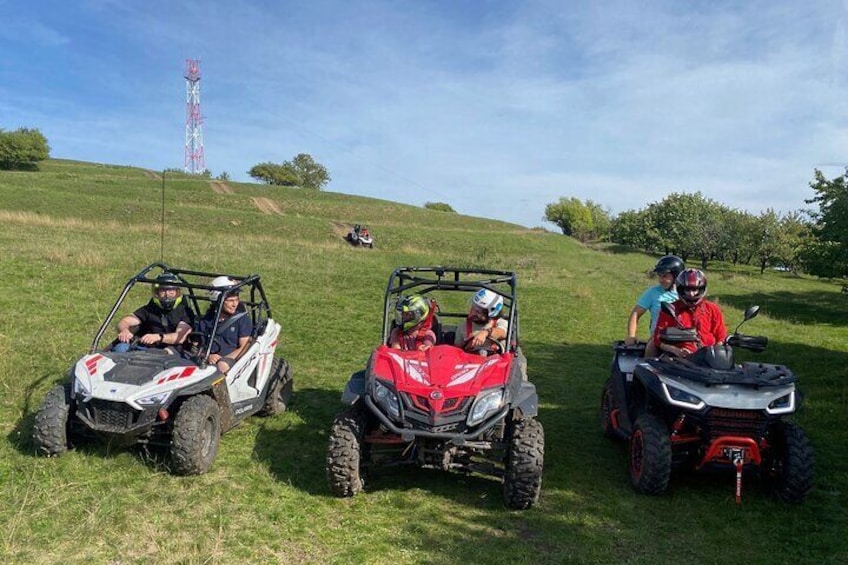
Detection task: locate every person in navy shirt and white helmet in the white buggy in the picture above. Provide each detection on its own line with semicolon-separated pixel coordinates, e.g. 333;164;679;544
197;276;253;374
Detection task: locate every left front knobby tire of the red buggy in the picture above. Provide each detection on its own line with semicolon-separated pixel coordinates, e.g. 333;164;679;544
327;406;366;496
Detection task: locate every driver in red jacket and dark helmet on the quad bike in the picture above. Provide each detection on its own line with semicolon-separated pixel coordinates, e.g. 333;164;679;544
653;269;727;357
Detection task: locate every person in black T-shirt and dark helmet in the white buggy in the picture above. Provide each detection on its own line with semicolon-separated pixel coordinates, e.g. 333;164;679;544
112;272;194;353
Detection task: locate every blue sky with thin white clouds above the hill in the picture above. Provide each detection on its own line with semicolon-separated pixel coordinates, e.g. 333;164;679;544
0;0;848;229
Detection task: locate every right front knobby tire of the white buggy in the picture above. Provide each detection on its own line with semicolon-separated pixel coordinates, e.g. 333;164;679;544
171;394;221;475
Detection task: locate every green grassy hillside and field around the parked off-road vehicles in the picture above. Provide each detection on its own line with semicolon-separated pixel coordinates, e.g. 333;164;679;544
0;160;848;564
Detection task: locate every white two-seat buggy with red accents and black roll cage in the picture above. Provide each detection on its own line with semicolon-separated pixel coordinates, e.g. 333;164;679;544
33;263;292;475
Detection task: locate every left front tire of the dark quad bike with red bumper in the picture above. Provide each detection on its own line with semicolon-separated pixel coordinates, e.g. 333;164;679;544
630;412;671;495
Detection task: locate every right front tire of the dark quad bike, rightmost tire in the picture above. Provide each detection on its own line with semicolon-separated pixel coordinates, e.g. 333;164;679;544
766;422;815;504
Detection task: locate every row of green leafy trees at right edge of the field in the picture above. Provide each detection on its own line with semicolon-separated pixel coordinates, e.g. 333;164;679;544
544;169;848;277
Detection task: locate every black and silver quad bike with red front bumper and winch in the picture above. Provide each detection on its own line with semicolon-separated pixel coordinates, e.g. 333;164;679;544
600;305;813;503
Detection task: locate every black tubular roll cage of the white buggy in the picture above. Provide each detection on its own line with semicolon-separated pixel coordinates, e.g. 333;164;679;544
89;263;272;359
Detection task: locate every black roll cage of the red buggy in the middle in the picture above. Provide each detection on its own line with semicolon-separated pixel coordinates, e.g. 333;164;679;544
382;267;519;351
